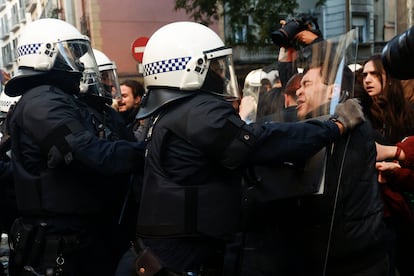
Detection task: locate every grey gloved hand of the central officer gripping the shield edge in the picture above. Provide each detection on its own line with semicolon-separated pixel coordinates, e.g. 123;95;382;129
333;98;365;132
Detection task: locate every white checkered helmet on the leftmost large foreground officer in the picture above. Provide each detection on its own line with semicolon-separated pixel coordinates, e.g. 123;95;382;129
6;18;103;96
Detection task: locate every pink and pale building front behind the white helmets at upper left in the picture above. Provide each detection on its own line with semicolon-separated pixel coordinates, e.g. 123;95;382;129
0;0;201;83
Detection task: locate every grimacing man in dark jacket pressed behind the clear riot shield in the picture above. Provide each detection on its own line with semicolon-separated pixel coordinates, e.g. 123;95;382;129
281;61;388;276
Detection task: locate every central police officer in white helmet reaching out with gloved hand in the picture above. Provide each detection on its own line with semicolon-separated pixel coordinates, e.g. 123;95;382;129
136;22;363;275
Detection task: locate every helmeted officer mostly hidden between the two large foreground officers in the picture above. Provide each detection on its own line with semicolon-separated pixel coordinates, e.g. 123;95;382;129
90;49;142;268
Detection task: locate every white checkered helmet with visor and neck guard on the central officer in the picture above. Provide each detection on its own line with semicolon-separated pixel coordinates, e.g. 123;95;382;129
137;22;239;118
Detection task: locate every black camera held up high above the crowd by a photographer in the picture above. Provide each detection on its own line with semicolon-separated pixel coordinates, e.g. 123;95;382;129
271;15;322;48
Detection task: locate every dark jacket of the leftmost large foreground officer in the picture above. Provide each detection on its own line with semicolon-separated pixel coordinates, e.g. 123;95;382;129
11;86;143;222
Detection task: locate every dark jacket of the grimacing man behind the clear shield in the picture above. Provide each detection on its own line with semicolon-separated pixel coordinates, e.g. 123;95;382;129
277;119;386;275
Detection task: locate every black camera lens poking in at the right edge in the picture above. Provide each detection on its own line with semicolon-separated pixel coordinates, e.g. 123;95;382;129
381;26;414;80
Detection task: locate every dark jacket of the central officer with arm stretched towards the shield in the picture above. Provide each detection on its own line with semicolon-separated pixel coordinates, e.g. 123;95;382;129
137;92;339;238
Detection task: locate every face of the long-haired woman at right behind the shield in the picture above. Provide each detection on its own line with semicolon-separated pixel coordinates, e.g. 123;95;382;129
362;61;386;97
